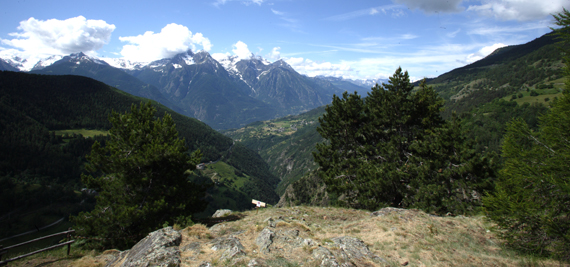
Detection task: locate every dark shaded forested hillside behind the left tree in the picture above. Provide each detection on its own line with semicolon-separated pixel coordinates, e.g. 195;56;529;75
0;71;278;241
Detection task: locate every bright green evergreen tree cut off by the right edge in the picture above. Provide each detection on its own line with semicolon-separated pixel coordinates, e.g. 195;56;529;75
484;9;570;261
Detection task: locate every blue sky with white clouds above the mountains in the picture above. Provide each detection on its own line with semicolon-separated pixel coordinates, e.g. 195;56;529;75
0;0;570;80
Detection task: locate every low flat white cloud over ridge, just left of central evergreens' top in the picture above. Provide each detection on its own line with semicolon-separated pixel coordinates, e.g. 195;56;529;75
285;57;354;77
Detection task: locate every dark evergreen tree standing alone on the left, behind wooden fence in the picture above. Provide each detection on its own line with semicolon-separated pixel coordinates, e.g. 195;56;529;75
72;103;205;249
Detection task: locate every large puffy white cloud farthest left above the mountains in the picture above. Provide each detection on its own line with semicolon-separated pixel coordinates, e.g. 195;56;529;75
1;16;115;56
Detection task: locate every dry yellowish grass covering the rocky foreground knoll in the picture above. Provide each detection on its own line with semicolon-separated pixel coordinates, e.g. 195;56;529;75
20;207;563;267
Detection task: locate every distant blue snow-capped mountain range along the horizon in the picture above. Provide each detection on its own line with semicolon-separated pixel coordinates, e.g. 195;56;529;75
0;50;372;130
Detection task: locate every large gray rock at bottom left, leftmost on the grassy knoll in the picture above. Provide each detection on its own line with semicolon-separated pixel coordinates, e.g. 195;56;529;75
113;227;182;267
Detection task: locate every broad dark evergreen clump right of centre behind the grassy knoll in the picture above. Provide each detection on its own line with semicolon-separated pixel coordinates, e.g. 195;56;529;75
314;68;493;213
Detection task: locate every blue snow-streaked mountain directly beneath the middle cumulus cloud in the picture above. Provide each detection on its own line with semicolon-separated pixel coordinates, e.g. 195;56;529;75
121;51;278;129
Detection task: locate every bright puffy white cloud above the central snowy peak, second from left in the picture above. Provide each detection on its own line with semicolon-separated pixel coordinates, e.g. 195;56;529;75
119;23;212;61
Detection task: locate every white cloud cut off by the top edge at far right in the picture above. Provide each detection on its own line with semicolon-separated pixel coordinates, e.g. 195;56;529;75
467;0;570;21
